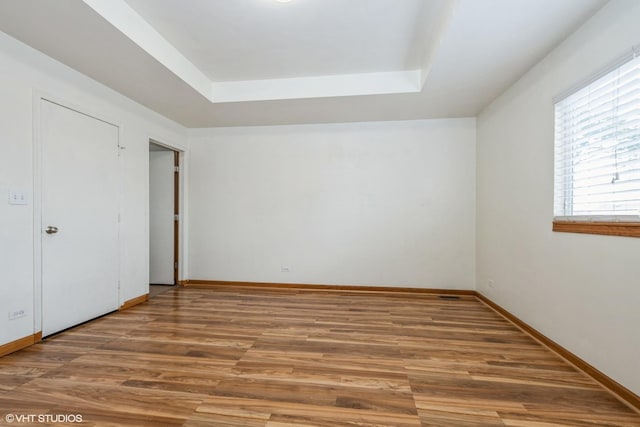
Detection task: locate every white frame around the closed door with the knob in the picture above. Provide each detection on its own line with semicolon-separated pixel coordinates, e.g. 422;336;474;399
32;94;123;334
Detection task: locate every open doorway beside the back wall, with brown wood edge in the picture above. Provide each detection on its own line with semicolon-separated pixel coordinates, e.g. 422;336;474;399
149;141;180;293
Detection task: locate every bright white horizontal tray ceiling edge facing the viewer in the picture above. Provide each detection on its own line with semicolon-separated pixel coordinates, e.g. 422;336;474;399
211;70;422;103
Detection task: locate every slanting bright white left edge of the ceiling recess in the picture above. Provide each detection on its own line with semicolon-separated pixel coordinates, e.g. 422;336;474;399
83;0;212;100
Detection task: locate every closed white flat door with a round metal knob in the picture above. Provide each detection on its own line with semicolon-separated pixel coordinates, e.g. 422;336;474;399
41;100;119;336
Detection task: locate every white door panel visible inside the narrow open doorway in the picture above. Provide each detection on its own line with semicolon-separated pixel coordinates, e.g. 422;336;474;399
149;150;175;285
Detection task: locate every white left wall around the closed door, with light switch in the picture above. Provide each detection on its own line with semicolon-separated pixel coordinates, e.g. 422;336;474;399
0;33;186;345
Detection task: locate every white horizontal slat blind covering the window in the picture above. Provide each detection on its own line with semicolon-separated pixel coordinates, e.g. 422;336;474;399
554;51;640;221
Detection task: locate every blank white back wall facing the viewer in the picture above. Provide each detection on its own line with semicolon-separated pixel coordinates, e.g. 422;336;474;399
189;119;475;289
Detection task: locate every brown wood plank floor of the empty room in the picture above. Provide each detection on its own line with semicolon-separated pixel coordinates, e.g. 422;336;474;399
0;287;640;427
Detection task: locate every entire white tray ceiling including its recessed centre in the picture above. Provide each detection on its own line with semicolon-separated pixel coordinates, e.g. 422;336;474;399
0;0;606;127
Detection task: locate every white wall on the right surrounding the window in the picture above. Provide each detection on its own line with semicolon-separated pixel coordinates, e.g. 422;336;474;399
477;0;640;393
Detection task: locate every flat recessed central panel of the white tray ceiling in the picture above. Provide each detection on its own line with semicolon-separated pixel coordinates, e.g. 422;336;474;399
126;0;428;81
